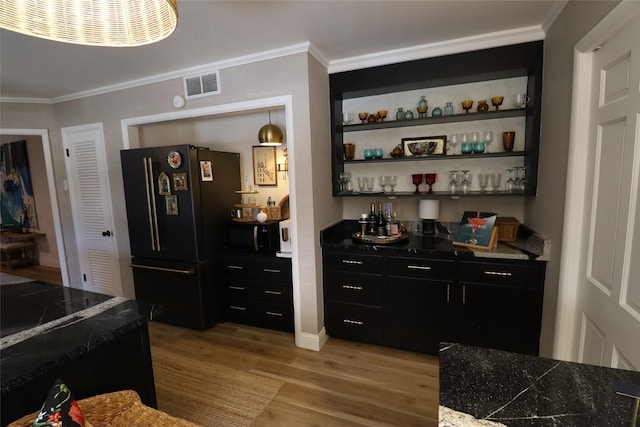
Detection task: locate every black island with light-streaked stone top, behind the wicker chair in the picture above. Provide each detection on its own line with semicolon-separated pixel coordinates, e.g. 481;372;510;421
0;282;156;425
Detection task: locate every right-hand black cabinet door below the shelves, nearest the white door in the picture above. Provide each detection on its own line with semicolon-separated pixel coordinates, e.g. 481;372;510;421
459;282;542;356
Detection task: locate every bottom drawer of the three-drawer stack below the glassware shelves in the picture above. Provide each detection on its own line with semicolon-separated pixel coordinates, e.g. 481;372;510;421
325;301;383;344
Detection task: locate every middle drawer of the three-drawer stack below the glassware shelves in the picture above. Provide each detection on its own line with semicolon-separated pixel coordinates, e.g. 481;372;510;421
324;271;383;306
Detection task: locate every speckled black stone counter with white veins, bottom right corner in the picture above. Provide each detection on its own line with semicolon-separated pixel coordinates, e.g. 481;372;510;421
440;344;640;427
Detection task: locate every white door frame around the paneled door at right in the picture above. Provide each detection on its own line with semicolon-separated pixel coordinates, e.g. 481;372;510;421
553;1;640;361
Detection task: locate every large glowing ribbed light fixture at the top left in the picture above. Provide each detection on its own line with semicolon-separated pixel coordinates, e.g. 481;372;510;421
0;0;178;47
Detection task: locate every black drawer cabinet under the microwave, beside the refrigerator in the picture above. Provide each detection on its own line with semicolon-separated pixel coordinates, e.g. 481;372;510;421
218;254;294;332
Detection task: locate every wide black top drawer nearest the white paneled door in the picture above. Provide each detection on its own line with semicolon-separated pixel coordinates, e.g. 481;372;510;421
460;261;546;291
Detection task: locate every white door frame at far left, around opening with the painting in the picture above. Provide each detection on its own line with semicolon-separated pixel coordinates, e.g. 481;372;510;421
0;128;69;287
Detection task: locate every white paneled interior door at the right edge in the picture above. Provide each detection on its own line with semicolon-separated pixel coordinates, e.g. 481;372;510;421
556;15;640;370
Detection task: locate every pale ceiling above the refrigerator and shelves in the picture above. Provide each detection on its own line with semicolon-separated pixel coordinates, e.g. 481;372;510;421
0;0;566;101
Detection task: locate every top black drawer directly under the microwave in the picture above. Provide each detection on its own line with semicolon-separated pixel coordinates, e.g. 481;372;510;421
221;256;291;282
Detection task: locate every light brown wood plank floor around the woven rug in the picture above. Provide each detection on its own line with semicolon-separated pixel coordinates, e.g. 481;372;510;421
149;322;439;426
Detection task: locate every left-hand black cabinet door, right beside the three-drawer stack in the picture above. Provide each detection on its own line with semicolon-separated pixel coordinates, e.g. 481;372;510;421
384;277;450;354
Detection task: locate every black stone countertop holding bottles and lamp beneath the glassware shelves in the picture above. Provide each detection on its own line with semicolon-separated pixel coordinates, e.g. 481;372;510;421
320;220;550;261
